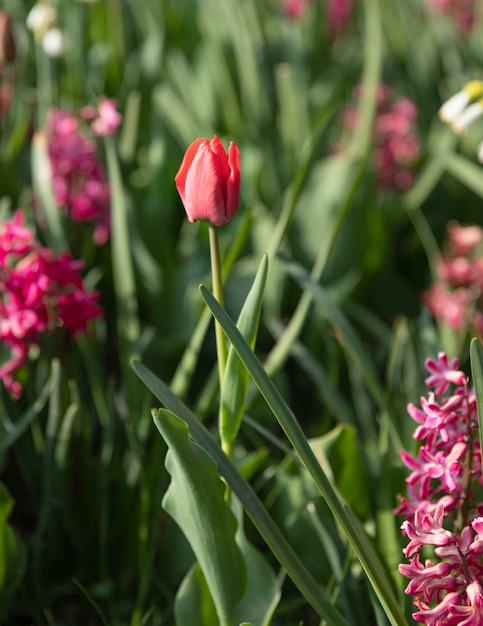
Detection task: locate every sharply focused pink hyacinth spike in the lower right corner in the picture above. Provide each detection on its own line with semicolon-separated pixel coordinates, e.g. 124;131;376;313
396;353;483;626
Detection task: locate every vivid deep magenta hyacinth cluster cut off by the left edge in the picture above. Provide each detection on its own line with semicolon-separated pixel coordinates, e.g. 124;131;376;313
0;210;102;398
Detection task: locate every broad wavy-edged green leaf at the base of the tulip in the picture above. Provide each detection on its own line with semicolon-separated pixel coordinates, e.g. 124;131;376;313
153;409;246;624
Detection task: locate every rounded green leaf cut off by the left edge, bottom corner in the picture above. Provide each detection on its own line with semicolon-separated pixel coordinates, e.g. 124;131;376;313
0;483;26;614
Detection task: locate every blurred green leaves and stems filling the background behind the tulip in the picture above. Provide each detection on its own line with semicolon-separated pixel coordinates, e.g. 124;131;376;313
0;0;483;626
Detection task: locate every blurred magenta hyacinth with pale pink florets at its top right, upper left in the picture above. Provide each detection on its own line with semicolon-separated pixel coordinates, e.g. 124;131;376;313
47;98;121;245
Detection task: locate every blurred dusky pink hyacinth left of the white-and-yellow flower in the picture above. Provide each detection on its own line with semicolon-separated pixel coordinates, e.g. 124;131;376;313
337;84;421;190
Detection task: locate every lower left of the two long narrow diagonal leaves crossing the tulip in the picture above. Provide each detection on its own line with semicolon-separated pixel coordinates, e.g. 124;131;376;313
132;361;347;626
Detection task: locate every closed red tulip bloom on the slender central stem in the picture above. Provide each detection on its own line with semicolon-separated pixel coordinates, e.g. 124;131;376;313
175;135;240;226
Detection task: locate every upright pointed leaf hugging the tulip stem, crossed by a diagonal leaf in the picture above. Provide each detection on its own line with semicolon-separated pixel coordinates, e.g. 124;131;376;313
220;255;268;445
